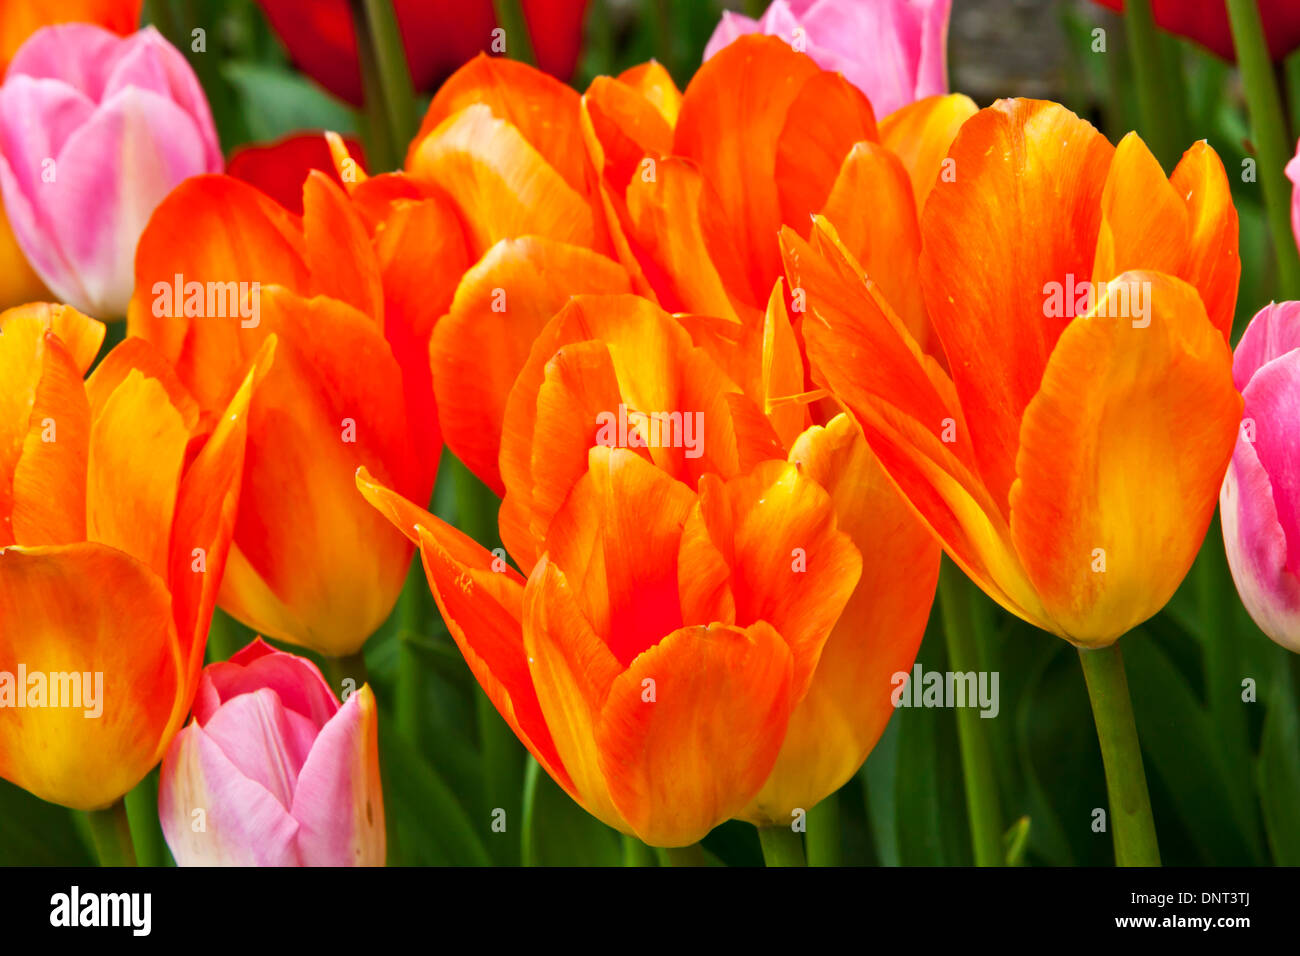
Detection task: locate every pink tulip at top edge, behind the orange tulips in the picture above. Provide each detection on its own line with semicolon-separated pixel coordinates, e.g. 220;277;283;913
705;0;953;117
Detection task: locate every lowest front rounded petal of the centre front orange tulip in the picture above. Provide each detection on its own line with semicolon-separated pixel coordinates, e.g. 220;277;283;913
595;622;793;847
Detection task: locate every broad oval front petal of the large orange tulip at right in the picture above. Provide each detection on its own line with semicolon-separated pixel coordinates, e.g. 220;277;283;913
1011;272;1242;646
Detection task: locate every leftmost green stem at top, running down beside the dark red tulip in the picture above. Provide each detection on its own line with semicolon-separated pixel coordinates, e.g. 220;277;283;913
351;0;417;172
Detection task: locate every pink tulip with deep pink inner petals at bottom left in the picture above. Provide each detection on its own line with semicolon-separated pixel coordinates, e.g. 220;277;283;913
159;639;385;866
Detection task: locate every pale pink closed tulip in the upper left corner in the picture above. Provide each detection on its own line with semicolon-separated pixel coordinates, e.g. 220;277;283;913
0;23;221;319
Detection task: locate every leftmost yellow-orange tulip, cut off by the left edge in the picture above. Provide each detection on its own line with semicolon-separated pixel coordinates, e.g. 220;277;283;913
0;304;263;809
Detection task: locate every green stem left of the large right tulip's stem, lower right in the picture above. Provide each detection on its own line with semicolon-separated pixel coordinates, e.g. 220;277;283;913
939;561;1006;866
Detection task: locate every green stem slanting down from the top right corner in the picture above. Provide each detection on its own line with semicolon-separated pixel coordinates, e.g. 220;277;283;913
1227;0;1300;299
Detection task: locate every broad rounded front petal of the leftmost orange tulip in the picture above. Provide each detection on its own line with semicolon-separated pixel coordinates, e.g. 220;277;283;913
0;542;181;809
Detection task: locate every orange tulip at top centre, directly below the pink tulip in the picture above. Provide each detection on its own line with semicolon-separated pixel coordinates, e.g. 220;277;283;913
582;36;975;358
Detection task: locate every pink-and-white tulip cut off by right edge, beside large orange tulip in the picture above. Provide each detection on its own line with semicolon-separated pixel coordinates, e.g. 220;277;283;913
1219;302;1300;652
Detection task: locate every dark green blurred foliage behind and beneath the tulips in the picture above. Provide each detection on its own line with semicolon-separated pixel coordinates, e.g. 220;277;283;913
0;0;1300;865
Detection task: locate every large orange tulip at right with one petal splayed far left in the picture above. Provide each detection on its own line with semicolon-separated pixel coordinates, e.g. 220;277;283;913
783;100;1242;648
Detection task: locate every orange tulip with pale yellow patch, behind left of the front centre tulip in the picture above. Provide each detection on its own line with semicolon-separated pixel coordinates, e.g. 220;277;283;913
406;56;631;494
